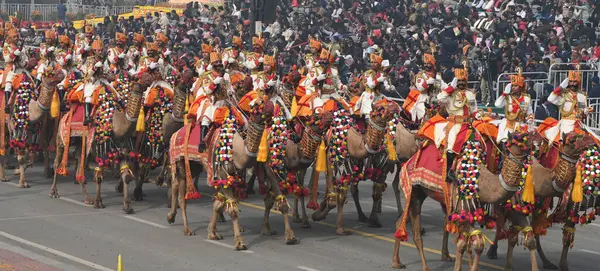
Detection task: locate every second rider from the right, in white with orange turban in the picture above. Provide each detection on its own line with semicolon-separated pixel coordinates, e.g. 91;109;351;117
495;74;533;143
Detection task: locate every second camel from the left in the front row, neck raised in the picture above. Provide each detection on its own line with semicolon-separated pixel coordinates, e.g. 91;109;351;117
50;71;152;214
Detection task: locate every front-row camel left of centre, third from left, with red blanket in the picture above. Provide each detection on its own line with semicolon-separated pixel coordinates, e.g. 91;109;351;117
167;98;274;250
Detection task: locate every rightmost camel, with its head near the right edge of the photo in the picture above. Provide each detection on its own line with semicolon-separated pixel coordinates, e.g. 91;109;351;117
487;132;594;270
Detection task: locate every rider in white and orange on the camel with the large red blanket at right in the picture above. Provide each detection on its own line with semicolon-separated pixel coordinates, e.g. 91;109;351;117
418;68;481;181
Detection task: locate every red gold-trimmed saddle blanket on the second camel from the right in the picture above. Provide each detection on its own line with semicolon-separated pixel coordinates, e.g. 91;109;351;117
400;144;446;202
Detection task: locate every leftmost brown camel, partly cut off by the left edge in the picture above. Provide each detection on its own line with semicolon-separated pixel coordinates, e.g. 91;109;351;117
0;67;64;188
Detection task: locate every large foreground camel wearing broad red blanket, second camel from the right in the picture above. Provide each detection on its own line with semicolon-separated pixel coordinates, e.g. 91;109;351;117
392;130;533;271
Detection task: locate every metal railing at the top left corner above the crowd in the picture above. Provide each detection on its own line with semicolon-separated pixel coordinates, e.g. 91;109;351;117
0;4;139;21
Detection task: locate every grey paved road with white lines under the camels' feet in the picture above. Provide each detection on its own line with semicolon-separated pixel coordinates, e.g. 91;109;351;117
0;164;600;271
